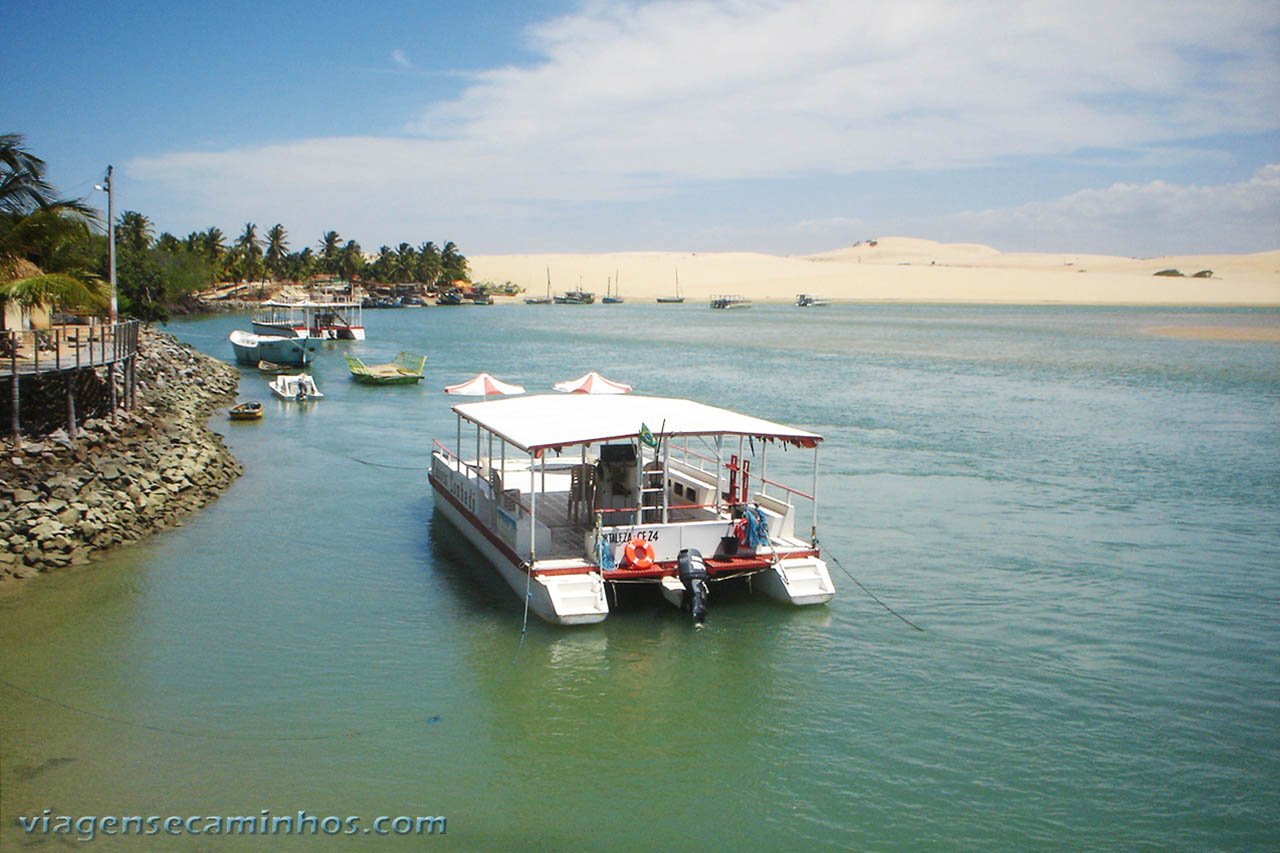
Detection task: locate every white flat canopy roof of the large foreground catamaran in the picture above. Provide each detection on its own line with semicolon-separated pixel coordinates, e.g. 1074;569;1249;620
453;394;822;456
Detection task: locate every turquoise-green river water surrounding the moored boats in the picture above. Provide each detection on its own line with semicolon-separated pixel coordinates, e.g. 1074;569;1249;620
0;304;1280;850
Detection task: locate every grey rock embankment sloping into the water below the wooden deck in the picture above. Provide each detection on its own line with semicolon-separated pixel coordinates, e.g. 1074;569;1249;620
0;329;243;584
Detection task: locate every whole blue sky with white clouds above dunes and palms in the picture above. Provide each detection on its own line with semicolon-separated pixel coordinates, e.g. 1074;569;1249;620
0;0;1280;256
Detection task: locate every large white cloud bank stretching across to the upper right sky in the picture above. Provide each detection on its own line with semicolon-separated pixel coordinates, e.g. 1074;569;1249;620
122;0;1280;249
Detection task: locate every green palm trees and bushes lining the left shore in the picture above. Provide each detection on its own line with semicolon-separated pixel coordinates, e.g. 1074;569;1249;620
0;134;470;321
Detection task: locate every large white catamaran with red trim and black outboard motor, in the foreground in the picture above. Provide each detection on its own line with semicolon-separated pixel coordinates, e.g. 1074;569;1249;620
429;394;835;625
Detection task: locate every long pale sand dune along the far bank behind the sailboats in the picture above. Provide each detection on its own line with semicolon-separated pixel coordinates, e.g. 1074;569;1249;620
468;237;1280;306
